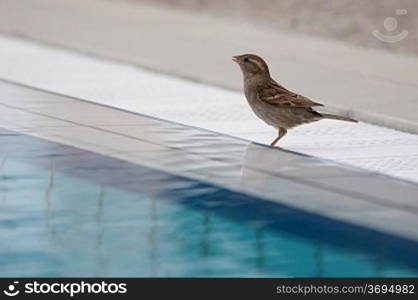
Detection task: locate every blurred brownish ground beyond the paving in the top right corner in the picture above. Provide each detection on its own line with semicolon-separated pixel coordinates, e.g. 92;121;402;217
131;0;418;55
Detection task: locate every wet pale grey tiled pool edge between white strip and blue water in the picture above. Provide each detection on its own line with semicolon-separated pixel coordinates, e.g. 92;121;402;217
0;81;418;241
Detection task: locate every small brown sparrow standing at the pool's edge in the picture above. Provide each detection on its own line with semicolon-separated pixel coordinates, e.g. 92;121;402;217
233;54;357;146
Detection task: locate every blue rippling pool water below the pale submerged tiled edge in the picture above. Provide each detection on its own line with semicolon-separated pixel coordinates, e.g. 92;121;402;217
0;131;418;277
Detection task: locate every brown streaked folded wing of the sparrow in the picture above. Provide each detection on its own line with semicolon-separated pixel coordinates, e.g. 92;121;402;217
257;81;323;108
